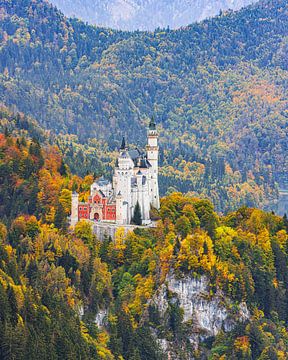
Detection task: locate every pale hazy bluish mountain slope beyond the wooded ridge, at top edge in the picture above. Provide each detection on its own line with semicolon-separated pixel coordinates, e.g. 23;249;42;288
51;0;256;30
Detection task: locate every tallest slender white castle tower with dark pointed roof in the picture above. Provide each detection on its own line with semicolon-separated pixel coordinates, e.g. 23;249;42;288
146;117;160;209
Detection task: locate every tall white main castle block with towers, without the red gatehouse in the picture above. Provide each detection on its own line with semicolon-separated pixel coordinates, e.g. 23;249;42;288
113;120;160;225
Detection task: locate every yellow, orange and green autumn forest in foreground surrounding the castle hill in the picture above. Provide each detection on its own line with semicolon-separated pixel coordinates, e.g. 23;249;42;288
0;130;288;360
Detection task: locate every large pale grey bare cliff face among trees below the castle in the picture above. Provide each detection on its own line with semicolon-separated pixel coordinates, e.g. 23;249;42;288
151;274;250;359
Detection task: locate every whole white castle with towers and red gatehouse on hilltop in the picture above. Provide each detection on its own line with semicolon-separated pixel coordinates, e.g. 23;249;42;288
71;119;160;227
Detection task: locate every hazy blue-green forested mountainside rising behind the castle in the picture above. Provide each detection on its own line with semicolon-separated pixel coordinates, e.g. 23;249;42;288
0;0;288;211
